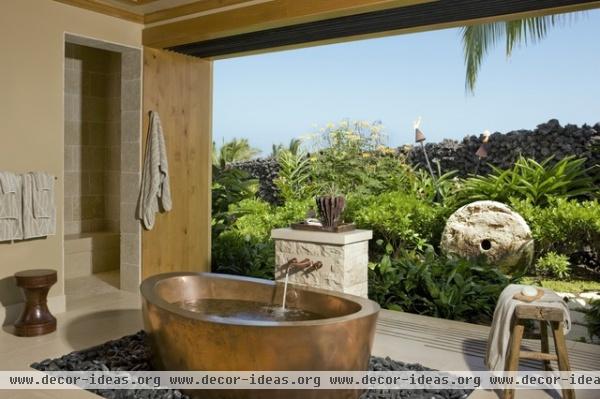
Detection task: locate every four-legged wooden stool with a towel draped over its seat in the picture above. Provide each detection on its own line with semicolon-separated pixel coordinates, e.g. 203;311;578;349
504;305;575;399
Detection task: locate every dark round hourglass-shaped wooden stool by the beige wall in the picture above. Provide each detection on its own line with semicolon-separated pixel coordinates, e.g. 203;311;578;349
15;269;57;337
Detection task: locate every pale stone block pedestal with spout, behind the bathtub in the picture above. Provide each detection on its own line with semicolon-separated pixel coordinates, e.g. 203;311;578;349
271;228;373;298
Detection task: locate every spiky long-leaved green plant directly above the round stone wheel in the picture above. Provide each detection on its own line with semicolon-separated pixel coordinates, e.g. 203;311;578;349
460;156;595;206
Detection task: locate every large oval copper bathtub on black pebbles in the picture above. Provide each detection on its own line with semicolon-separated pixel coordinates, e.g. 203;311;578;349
141;272;379;399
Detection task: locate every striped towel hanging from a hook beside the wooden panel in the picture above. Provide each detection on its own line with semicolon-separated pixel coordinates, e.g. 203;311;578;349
138;111;172;230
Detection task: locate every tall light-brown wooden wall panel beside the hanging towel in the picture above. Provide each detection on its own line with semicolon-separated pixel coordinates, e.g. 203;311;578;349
142;47;212;278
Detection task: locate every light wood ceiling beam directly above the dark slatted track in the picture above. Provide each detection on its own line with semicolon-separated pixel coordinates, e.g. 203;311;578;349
142;0;439;48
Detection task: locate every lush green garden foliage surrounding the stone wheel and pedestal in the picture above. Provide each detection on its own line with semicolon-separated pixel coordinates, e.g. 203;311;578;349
212;121;600;322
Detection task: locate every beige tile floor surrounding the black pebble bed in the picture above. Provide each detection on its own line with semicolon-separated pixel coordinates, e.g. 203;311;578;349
0;273;600;399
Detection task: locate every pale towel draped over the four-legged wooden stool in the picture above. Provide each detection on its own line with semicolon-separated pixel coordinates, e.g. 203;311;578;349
485;284;571;371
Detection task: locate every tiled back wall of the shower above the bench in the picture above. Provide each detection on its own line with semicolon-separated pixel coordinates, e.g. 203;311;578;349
65;43;121;235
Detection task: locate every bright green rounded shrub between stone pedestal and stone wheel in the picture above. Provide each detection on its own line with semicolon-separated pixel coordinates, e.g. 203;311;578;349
344;191;446;255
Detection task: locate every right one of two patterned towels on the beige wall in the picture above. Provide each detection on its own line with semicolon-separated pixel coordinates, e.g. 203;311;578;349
22;173;56;239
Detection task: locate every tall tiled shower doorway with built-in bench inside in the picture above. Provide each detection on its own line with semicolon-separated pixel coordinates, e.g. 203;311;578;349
64;34;141;297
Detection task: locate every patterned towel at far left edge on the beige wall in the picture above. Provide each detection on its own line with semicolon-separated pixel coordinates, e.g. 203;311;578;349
0;172;23;241
